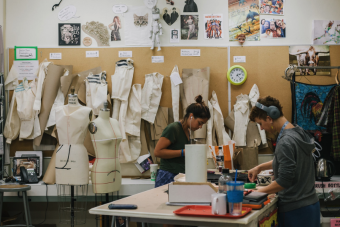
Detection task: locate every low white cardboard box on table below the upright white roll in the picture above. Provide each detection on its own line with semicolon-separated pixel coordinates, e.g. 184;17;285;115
168;182;218;204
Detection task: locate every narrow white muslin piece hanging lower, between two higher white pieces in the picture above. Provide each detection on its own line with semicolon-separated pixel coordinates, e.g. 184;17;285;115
125;84;142;136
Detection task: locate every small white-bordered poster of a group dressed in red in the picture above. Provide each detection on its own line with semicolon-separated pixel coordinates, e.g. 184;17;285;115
204;14;223;39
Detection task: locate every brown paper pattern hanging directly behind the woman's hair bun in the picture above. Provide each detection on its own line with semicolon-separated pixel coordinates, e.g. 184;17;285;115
180;67;210;139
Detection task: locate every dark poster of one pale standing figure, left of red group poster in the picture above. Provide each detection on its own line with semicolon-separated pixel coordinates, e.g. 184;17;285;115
181;15;199;40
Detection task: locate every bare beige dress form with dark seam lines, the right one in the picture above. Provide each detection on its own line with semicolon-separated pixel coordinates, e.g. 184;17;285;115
89;102;122;194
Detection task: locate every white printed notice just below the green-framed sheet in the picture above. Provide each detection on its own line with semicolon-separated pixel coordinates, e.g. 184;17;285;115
12;60;39;80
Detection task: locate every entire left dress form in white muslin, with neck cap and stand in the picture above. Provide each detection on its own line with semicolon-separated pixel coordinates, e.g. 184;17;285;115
55;88;92;227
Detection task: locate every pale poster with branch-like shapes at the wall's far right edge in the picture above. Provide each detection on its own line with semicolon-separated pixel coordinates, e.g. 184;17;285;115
313;20;340;45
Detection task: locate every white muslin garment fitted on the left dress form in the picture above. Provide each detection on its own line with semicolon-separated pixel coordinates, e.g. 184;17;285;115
55;105;92;185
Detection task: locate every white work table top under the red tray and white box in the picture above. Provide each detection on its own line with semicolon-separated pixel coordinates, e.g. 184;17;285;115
89;185;277;226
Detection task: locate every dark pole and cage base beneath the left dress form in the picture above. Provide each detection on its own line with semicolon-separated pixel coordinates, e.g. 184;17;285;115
57;184;88;227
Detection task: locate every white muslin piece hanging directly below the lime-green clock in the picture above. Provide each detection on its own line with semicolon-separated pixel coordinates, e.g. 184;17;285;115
233;94;250;146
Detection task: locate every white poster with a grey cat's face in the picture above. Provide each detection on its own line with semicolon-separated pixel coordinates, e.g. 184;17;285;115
124;6;152;46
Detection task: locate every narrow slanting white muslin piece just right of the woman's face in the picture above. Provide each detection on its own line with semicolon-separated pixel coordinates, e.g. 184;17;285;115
210;91;230;146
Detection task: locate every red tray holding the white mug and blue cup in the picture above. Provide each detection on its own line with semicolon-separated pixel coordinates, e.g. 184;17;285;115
174;205;252;218
